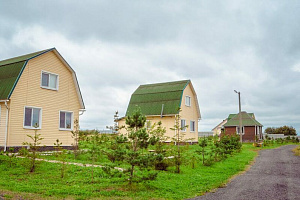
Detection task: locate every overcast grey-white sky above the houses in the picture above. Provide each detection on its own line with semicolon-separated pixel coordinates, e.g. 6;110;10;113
0;0;300;133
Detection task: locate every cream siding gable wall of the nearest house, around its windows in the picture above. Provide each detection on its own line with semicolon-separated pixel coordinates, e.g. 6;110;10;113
8;52;80;146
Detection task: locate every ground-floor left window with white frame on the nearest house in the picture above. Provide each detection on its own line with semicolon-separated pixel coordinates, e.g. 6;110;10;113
23;106;42;129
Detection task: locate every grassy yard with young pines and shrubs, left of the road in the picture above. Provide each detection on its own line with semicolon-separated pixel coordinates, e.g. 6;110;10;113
0;110;298;199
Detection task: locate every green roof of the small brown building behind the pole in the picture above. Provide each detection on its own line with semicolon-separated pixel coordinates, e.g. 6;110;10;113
224;112;263;127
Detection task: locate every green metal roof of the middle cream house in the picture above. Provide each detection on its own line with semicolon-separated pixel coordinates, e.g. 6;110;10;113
126;80;190;116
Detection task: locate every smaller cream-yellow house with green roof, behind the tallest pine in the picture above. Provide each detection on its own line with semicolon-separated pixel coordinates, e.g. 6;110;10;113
118;80;201;142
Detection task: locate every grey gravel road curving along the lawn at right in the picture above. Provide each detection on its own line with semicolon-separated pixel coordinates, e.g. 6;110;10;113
189;145;300;200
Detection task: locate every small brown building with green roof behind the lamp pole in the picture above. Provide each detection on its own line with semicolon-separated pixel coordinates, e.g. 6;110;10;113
223;111;263;142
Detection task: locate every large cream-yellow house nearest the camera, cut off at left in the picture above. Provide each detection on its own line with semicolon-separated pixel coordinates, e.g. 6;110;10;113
0;48;85;150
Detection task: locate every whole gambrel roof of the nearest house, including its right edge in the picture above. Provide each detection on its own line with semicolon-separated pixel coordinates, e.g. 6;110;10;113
0;48;85;109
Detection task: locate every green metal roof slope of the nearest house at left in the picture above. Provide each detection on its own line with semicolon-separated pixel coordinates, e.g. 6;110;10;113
0;49;52;100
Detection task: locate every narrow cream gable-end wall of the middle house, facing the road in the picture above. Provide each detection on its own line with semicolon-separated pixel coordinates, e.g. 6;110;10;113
180;83;200;141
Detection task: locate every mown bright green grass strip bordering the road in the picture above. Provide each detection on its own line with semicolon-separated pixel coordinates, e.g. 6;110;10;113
0;144;292;199
